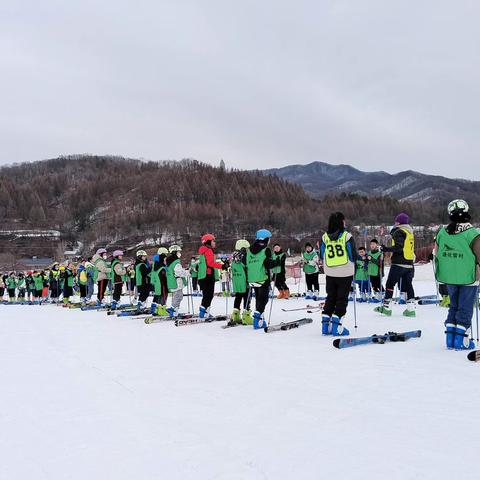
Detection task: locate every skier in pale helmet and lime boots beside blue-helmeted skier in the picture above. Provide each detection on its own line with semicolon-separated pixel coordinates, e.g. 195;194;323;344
231;239;253;325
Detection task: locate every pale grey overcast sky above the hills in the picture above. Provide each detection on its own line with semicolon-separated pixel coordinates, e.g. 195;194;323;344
0;0;480;180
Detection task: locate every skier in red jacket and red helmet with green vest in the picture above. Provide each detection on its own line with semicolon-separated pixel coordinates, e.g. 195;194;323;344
198;233;228;318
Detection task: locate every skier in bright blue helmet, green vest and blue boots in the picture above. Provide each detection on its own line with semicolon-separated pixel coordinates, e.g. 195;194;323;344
247;228;281;329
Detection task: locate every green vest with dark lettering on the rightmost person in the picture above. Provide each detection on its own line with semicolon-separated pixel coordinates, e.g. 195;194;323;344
435;227;480;285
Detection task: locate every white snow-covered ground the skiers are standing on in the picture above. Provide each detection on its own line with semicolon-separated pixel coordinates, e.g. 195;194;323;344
0;266;480;480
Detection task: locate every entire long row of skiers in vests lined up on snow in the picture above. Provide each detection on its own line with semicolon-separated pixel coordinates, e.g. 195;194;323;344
0;200;480;349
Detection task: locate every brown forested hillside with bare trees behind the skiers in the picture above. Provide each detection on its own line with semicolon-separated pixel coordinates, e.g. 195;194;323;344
0;155;441;253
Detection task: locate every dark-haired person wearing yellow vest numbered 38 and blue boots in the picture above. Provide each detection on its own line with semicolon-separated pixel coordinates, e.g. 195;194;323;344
320;212;357;336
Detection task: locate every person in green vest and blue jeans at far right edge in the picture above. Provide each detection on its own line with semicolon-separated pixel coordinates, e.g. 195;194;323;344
435;199;480;350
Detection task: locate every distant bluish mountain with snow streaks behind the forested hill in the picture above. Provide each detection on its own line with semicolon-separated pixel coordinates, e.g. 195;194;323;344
263;162;480;206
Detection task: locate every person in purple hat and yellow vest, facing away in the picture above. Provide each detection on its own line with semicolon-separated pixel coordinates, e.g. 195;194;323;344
374;212;416;317
